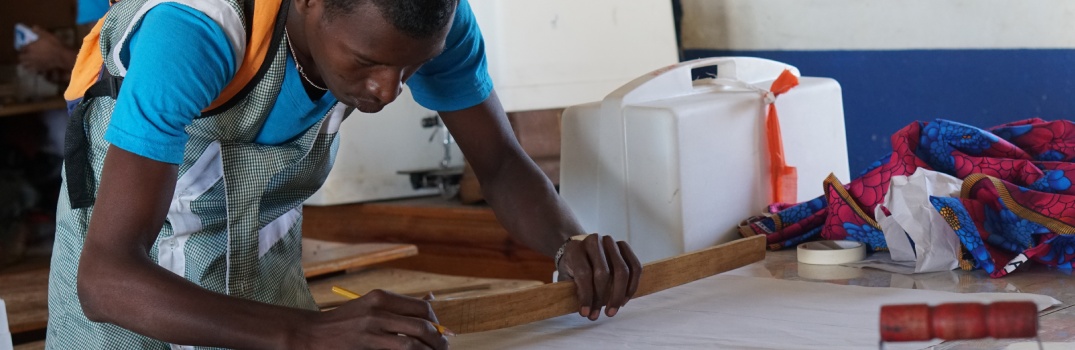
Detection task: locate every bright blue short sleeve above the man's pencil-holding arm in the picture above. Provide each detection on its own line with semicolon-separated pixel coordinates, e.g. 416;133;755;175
104;3;237;164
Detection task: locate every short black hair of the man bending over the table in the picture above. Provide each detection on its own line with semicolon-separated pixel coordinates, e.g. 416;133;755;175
325;0;459;39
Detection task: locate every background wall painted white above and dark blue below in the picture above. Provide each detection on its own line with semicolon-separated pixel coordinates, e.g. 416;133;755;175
682;0;1075;174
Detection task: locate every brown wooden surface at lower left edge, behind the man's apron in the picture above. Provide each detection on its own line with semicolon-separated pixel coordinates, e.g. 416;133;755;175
0;257;48;334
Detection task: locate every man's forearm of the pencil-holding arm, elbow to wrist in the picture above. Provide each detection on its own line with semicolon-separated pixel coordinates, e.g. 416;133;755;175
78;247;316;349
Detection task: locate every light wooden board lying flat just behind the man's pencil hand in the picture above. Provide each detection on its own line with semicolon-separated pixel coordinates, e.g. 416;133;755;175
310;268;542;308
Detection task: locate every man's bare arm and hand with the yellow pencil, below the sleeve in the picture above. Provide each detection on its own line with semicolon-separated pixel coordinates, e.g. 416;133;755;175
74;146;448;350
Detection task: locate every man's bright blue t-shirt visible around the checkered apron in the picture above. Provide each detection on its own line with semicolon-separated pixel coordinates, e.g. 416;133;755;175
104;0;492;164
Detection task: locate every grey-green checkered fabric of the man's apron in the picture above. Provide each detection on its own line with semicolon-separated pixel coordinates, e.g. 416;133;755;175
46;0;338;349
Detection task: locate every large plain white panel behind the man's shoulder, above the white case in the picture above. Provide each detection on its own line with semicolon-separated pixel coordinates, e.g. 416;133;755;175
470;0;678;112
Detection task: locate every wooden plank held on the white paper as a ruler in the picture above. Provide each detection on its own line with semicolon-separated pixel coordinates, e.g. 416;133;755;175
431;236;765;334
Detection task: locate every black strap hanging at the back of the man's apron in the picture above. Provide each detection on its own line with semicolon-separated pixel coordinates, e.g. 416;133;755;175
63;67;124;209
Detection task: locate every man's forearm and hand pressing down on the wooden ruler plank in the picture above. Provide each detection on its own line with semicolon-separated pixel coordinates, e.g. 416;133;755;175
441;92;642;320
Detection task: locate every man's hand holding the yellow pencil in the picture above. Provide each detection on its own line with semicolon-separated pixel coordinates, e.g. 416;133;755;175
289;290;448;349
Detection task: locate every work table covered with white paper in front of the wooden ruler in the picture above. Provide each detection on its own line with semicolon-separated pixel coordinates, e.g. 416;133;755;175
452;250;1075;350
